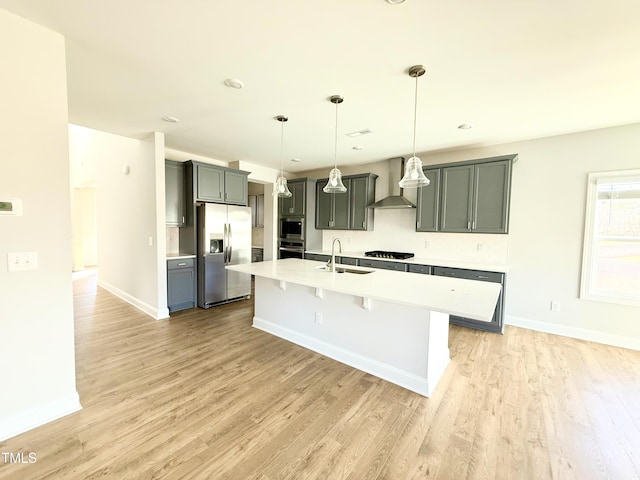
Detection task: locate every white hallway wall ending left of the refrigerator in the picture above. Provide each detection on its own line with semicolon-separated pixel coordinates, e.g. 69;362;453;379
69;126;169;318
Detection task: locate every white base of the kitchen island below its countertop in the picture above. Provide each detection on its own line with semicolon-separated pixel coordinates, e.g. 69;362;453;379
253;277;449;396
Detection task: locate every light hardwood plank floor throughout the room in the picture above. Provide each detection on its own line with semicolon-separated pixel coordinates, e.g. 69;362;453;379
0;277;640;480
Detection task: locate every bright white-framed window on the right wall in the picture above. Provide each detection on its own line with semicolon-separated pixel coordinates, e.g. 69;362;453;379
580;170;640;306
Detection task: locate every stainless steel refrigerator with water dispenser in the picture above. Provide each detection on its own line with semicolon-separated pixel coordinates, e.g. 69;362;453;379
198;203;251;308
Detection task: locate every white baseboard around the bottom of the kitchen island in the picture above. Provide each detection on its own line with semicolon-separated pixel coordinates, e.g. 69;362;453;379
253;317;438;397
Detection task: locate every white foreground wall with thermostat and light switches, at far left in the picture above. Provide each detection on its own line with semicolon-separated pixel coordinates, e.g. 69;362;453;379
0;10;80;440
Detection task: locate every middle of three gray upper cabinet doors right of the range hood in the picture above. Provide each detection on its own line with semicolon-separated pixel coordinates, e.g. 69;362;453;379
440;165;474;232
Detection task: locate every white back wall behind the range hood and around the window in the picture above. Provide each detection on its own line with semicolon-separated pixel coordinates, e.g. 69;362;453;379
299;124;640;350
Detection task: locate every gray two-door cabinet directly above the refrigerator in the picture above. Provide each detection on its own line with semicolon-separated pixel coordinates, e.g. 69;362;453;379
194;163;249;205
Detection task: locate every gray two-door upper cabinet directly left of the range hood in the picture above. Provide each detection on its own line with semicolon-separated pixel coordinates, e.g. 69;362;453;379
316;173;378;230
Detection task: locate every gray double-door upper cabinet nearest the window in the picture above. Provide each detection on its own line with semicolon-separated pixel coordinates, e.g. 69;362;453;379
440;155;515;233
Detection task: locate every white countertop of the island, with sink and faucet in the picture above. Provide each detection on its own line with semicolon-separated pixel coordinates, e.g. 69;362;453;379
226;254;502;322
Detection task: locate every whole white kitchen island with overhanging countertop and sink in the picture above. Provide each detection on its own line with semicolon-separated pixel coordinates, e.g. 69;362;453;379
227;259;500;396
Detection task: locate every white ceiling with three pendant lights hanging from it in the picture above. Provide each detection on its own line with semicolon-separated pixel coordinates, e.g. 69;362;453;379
0;0;640;172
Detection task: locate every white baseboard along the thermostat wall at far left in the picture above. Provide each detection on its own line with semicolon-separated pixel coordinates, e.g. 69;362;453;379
0;392;82;442
